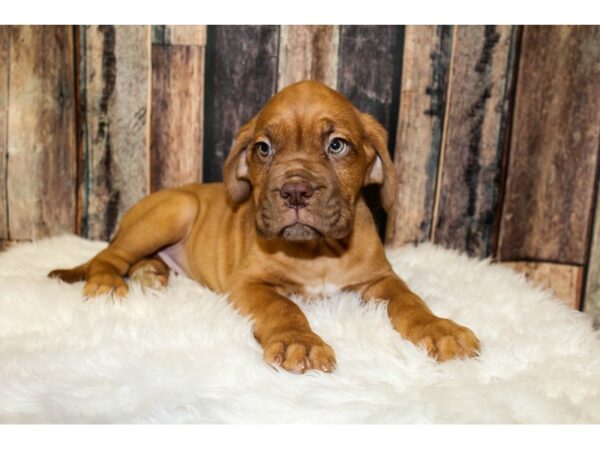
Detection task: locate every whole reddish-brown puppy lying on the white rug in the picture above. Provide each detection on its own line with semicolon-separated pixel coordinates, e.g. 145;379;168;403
50;81;479;372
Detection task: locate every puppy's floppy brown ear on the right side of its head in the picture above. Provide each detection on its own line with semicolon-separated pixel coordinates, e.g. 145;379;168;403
360;113;398;212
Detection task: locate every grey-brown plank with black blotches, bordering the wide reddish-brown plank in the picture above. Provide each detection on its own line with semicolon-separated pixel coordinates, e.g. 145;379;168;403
432;26;517;257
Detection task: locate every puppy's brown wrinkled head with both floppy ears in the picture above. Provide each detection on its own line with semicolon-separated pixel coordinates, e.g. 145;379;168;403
224;81;397;241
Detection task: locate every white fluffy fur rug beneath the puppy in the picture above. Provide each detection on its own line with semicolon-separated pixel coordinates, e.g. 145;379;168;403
0;236;600;423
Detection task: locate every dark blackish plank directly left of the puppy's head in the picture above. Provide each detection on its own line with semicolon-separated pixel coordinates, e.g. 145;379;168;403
203;25;278;182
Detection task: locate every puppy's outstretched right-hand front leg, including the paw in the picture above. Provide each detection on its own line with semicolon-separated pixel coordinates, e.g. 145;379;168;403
363;274;479;361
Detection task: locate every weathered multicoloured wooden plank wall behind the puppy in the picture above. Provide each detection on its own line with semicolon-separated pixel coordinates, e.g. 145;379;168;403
0;25;600;320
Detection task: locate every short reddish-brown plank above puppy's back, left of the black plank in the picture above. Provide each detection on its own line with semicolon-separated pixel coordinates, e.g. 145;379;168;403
151;45;204;191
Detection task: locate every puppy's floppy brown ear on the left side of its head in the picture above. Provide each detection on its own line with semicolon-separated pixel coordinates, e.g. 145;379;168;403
223;119;256;203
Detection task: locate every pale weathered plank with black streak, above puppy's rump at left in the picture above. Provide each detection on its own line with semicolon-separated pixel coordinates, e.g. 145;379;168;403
82;26;151;239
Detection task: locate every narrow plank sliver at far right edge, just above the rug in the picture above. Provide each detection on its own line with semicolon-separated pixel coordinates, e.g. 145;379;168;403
583;183;600;325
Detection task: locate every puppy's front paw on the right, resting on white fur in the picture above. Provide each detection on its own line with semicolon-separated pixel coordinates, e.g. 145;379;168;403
407;317;479;361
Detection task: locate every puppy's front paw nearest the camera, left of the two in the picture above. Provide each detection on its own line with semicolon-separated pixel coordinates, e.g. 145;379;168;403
263;331;336;373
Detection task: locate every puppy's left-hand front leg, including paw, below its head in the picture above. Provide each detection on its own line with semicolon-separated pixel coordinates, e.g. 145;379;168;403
229;282;335;373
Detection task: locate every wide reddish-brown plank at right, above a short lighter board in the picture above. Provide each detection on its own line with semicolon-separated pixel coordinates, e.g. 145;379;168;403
499;26;600;264
